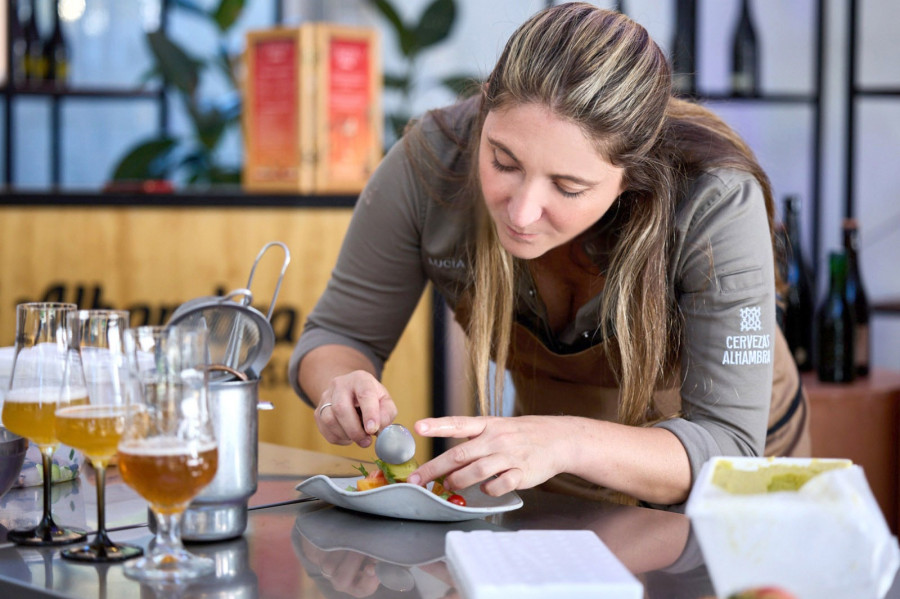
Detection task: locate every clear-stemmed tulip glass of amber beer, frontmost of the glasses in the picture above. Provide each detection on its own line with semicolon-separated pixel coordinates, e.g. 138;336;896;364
119;326;218;582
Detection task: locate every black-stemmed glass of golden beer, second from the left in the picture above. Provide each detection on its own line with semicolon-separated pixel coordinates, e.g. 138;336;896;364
56;310;143;562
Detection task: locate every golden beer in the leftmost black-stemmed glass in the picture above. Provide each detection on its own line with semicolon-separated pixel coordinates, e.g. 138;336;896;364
3;387;88;448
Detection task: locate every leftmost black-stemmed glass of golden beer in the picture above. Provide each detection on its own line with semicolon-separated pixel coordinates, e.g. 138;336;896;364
3;302;87;546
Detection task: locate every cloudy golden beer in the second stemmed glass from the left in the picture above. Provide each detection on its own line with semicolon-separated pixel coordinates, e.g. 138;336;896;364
56;405;135;466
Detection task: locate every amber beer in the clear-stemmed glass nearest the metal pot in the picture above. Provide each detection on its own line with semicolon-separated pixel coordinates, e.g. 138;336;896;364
119;437;219;514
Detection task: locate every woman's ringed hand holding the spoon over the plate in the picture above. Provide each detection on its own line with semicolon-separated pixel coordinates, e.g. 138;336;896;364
315;370;397;447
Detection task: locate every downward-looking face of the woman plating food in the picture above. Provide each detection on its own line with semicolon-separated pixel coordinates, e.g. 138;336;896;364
478;104;623;260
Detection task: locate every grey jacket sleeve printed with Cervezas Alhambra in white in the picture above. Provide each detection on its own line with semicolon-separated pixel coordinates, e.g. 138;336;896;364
657;170;776;492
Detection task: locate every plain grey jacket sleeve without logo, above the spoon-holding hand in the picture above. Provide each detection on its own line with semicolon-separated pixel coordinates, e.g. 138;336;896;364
288;136;426;403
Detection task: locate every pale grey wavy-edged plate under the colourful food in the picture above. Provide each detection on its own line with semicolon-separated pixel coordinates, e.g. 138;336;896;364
296;474;522;522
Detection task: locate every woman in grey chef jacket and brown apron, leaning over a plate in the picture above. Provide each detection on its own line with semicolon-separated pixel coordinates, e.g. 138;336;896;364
290;3;808;506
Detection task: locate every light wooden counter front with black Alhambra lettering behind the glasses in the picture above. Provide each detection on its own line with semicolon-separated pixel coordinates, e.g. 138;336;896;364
0;206;431;460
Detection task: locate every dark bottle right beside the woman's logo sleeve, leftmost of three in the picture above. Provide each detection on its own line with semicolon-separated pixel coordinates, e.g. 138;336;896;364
782;195;815;372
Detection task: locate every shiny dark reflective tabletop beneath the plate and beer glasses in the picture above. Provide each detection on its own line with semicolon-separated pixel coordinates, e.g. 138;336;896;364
0;443;900;599
